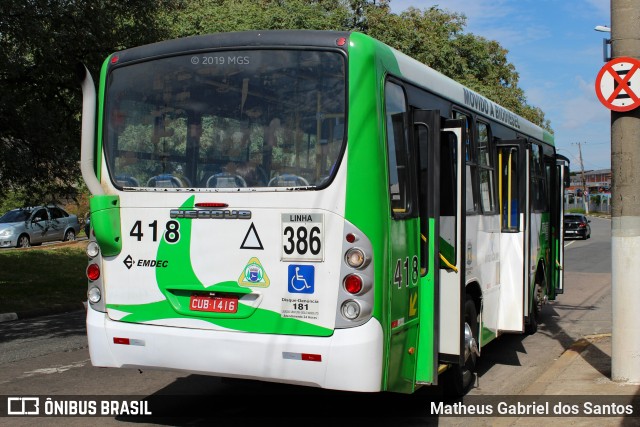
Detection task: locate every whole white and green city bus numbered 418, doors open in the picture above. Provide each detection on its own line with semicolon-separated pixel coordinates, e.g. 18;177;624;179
81;31;568;393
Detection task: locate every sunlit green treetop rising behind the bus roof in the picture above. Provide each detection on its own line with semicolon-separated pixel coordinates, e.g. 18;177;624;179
161;0;551;131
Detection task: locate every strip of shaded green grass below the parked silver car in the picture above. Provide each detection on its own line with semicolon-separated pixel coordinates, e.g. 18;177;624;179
0;241;87;313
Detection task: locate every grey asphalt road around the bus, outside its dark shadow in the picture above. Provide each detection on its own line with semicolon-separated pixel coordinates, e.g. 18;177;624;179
0;218;611;426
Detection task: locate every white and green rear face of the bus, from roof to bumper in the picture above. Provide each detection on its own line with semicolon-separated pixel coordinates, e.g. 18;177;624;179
83;32;383;391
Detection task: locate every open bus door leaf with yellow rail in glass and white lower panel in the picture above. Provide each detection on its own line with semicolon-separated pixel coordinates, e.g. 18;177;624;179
497;140;529;332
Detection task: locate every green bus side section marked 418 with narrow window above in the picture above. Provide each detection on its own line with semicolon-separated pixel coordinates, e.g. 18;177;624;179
385;81;420;393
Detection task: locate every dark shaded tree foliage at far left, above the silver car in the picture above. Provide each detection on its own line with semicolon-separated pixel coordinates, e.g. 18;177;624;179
0;0;172;204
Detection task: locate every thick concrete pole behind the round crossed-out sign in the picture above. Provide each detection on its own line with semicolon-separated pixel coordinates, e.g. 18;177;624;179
611;0;640;383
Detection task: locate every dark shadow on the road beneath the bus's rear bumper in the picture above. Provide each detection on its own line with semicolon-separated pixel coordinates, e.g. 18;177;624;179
117;375;439;426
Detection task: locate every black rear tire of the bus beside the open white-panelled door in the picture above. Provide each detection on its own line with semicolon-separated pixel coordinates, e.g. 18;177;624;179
443;294;478;397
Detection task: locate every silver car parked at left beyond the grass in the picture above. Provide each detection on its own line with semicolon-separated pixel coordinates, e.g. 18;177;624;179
0;206;80;248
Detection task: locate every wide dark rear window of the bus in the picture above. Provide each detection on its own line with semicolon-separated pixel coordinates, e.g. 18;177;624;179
103;50;346;190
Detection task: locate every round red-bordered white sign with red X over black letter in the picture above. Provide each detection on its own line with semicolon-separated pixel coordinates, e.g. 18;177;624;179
596;56;640;111
